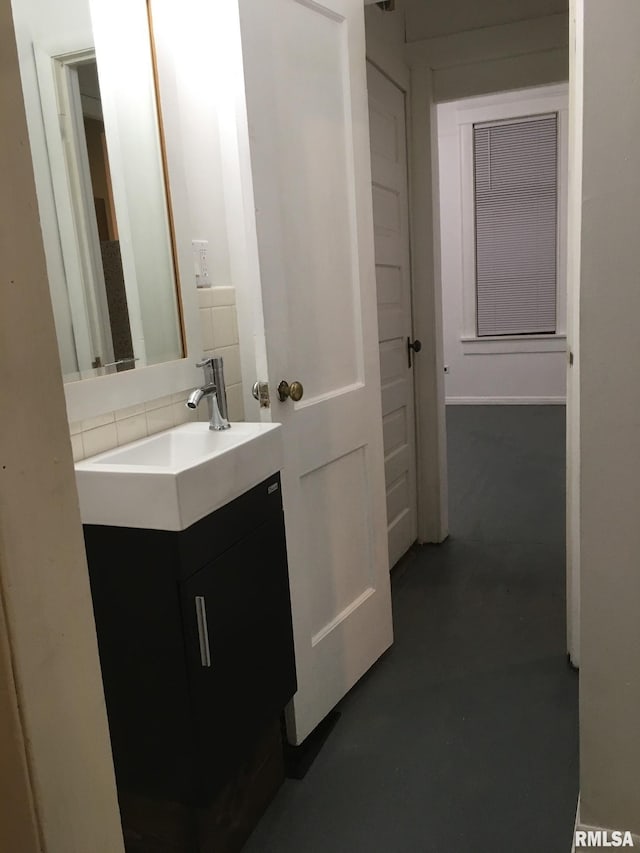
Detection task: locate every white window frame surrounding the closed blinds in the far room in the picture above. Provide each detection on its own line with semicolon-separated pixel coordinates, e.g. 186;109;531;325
456;84;569;355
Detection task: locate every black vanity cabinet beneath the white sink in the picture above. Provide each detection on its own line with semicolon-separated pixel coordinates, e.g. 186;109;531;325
84;475;296;853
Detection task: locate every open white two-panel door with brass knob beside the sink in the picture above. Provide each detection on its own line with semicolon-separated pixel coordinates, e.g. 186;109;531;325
240;0;392;743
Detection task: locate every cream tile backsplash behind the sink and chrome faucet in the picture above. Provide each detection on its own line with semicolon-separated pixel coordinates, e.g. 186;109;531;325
69;287;244;462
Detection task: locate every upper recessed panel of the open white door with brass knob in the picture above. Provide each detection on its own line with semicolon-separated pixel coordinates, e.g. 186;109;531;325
272;3;362;404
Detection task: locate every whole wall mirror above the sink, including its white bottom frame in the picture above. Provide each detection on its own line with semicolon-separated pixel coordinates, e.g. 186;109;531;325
12;0;201;421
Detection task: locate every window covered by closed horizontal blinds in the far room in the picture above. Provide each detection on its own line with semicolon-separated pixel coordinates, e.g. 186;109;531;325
473;114;558;337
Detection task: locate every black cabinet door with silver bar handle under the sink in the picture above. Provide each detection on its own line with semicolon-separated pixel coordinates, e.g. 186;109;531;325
182;519;296;798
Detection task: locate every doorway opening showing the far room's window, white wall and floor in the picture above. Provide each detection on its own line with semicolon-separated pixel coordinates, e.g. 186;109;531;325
436;78;569;644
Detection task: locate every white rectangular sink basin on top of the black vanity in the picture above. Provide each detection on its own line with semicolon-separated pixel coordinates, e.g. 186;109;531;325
75;422;283;530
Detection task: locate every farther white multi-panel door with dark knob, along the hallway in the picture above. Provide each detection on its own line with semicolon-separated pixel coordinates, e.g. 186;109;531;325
367;63;419;566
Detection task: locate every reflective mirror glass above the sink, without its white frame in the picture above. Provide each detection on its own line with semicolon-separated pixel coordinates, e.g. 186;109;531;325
23;0;185;381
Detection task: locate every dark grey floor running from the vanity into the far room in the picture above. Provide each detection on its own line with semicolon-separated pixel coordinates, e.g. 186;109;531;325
245;406;578;853
